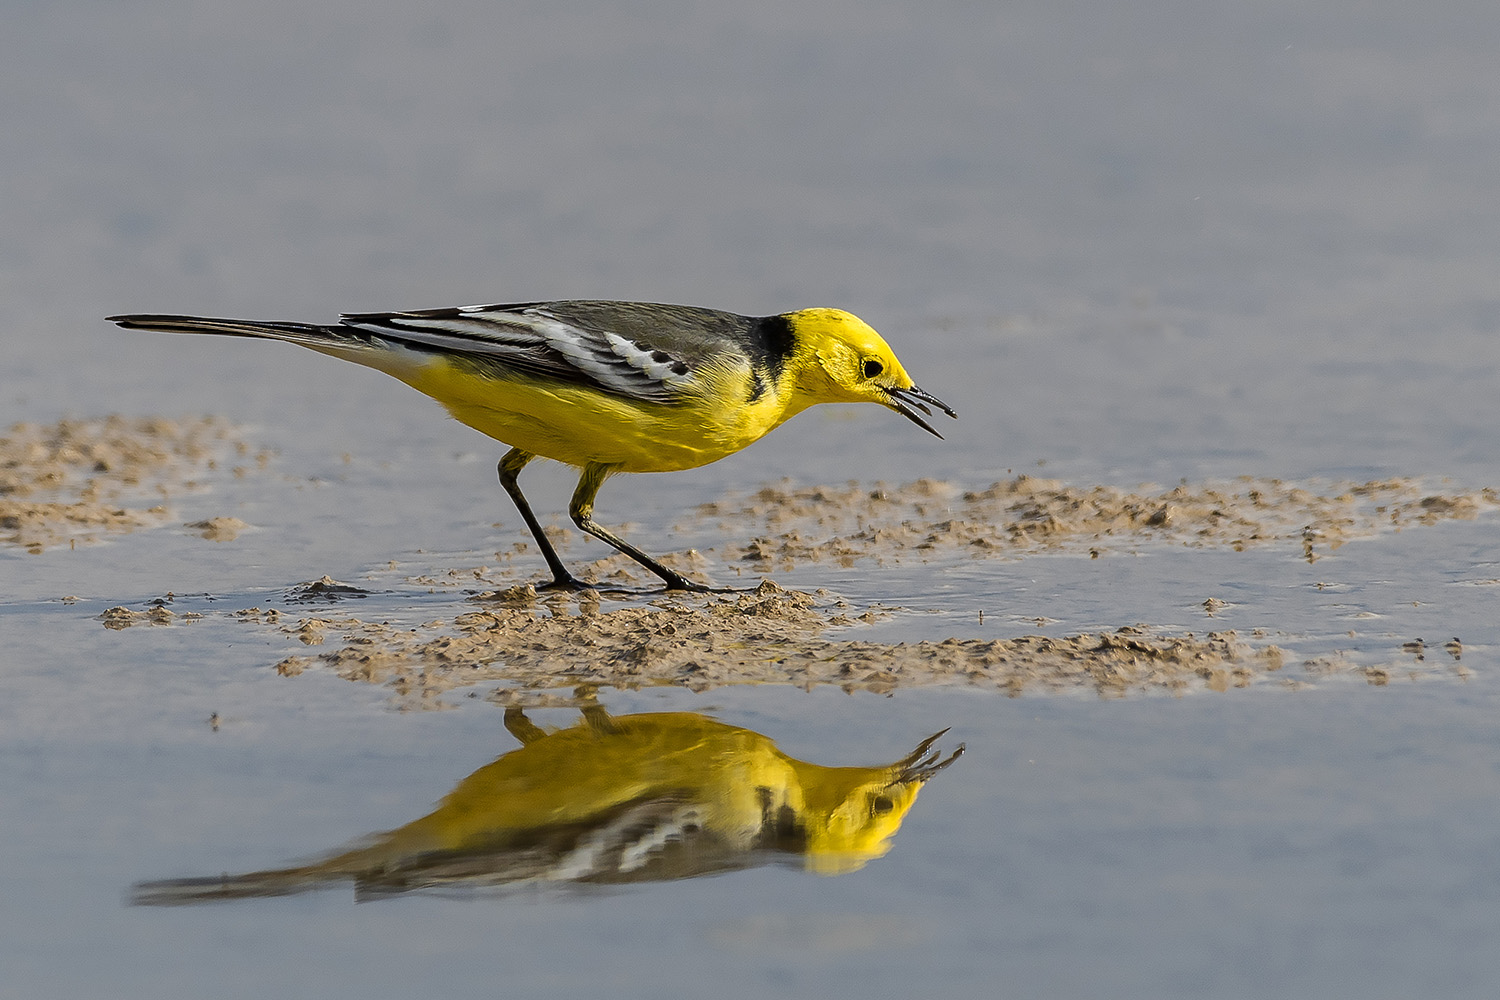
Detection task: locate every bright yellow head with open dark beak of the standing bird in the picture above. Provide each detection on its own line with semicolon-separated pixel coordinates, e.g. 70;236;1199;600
786;309;959;438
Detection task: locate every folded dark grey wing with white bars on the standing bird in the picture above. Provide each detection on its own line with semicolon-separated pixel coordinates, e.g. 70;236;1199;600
341;303;728;403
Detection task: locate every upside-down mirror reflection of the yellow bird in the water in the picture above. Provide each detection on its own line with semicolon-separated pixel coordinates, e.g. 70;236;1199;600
132;705;963;906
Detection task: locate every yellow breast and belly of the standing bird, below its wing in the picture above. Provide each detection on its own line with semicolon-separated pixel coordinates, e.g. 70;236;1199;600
392;357;803;472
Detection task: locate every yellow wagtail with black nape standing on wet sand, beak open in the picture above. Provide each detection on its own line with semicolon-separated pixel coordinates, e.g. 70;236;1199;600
108;300;959;592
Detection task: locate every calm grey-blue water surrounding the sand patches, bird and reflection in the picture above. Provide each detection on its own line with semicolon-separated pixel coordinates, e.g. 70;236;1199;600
0;0;1500;997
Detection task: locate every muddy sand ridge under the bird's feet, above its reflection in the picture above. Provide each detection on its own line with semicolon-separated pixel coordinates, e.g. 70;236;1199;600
246;580;1464;708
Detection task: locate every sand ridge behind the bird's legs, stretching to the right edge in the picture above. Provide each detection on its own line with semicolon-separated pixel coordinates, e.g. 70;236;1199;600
696;475;1500;570
